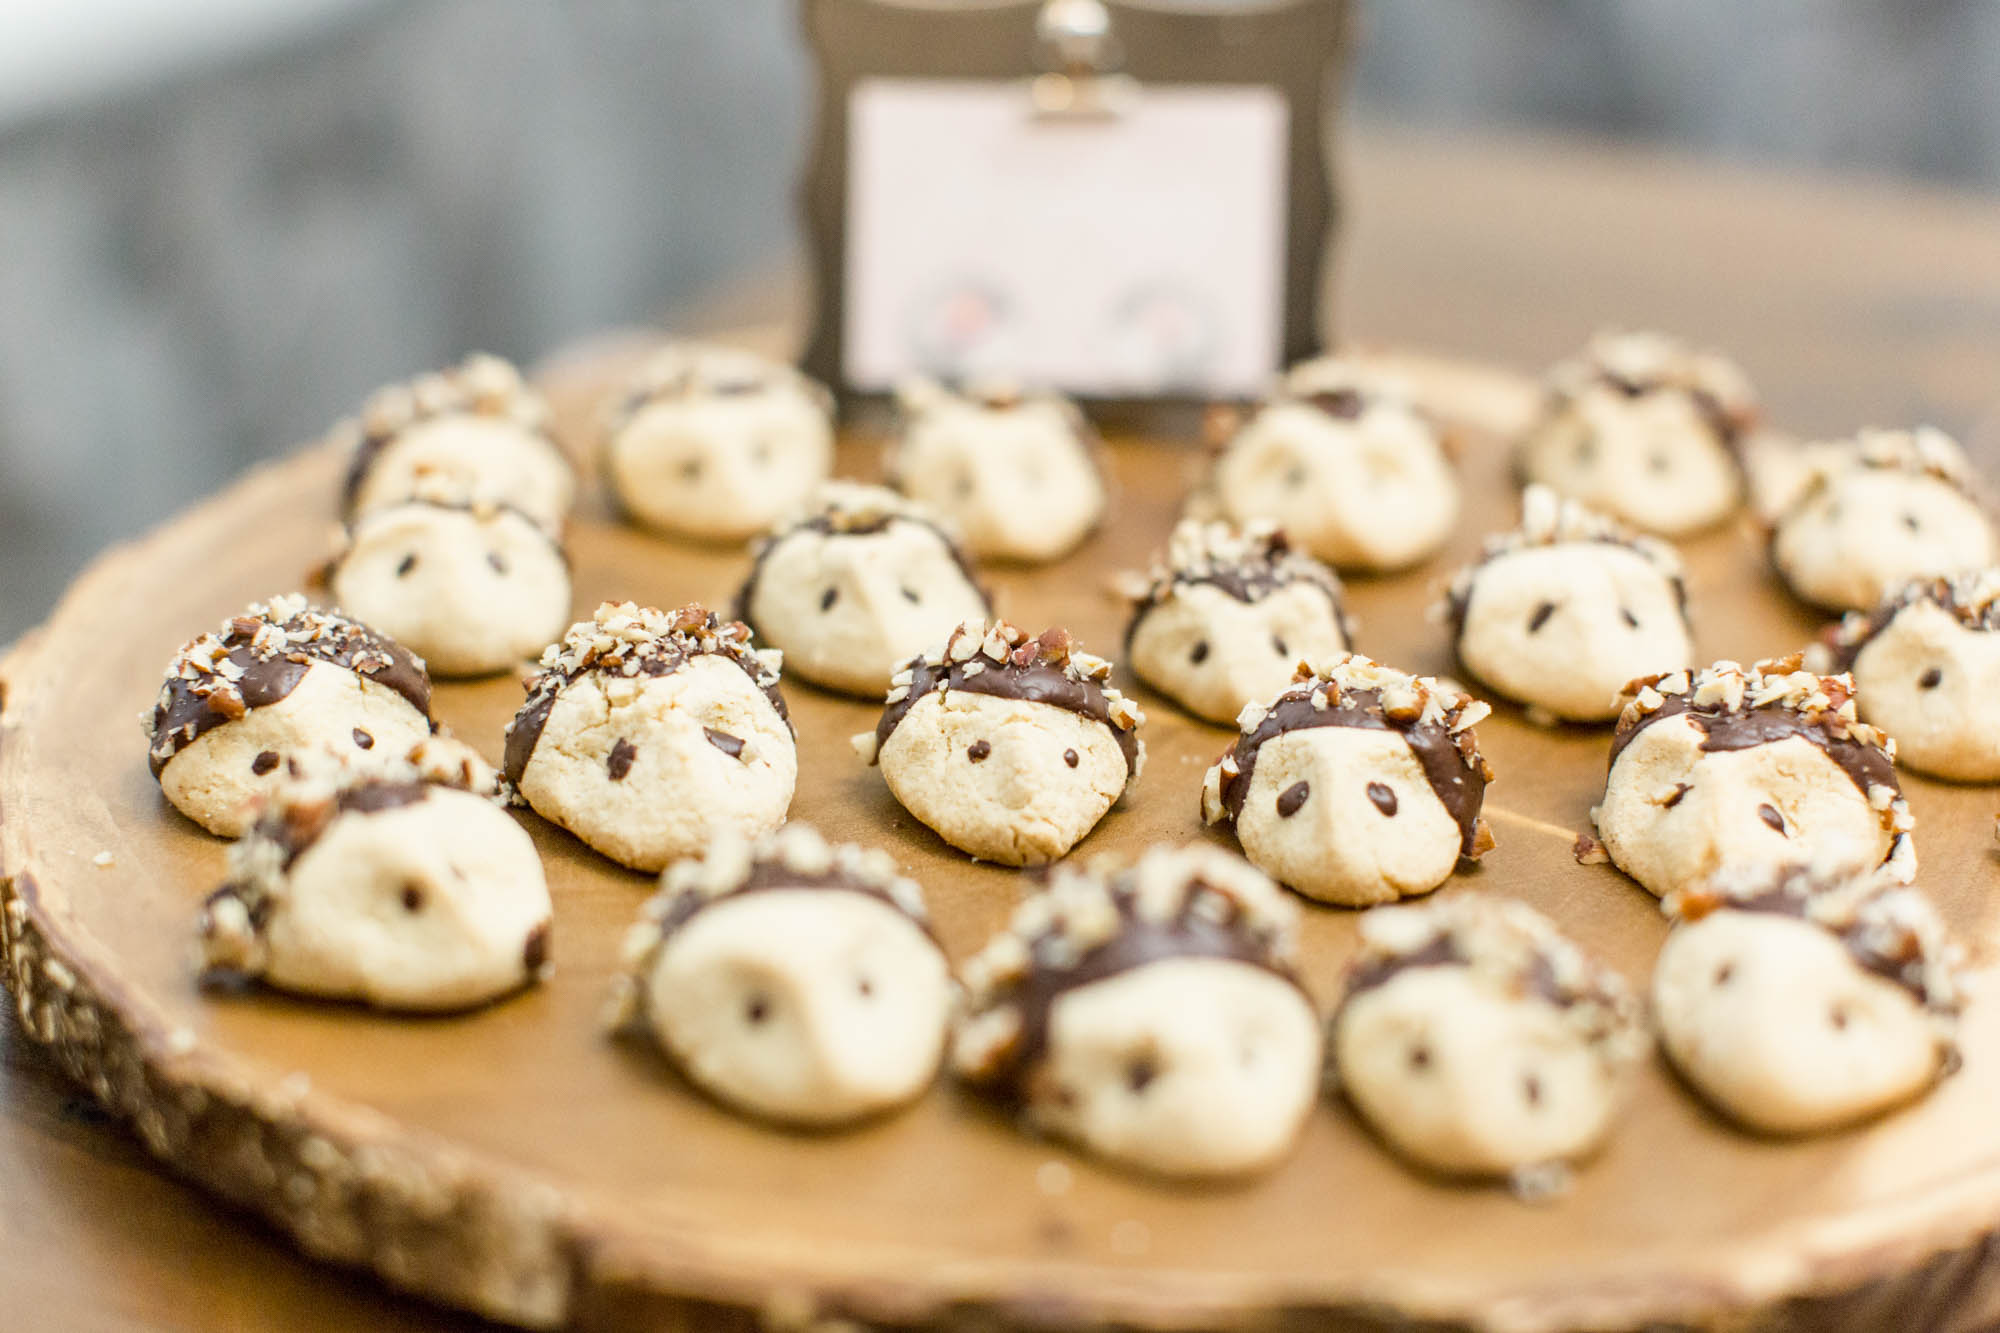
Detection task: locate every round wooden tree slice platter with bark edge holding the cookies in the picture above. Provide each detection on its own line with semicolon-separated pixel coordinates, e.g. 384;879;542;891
11;344;2000;1329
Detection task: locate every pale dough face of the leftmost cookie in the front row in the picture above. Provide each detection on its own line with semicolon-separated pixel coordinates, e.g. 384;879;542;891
264;787;552;1011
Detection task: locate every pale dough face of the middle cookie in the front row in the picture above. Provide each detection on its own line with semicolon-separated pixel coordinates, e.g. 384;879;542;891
1030;957;1322;1177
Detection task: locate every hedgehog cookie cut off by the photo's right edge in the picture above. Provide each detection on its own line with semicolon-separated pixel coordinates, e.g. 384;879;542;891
1826;568;2000;783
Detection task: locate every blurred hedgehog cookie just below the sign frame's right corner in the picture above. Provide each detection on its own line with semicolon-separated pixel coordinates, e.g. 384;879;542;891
1210;356;1458;570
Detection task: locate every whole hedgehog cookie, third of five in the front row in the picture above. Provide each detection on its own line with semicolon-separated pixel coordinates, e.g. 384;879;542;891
952;847;1322;1177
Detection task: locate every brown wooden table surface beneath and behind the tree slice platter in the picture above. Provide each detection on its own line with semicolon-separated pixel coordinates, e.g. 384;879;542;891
11;128;2000;1333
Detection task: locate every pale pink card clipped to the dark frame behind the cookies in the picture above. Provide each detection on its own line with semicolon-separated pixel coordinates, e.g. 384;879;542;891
842;78;1288;396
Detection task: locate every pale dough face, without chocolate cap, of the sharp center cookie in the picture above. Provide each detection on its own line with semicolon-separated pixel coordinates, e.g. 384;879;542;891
878;689;1128;865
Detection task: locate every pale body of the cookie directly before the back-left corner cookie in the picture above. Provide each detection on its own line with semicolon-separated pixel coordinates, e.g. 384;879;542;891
330;504;570;677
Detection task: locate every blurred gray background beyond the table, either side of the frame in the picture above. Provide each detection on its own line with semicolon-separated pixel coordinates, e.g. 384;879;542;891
0;0;2000;642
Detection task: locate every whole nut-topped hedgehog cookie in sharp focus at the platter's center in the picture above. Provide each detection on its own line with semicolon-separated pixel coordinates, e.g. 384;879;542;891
854;620;1146;865
